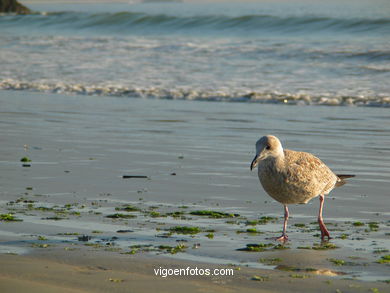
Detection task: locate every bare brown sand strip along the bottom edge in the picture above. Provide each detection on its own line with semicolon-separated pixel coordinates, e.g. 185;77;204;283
0;249;388;293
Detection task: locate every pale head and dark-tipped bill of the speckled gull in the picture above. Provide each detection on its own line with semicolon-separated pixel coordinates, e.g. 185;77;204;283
251;135;283;170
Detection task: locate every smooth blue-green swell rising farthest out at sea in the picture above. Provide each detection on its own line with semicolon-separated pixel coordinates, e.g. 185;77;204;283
0;12;390;34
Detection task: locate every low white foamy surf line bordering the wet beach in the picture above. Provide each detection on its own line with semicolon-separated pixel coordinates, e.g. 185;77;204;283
0;79;390;107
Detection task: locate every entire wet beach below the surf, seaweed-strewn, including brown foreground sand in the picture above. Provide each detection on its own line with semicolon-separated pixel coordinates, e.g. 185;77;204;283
0;91;390;292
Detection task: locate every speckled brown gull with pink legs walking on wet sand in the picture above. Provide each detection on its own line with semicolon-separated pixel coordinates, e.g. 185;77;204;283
250;135;355;242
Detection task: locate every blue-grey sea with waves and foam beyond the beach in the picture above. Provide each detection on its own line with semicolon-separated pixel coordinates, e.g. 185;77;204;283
0;0;390;107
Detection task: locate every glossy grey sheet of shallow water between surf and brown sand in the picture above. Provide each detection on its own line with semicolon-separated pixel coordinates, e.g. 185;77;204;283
0;91;390;280
